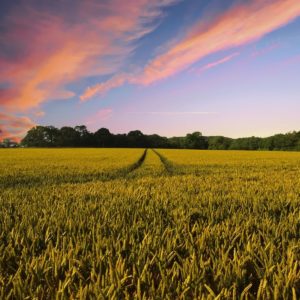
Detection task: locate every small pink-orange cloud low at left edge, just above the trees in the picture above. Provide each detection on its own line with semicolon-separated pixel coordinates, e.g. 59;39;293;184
0;113;35;142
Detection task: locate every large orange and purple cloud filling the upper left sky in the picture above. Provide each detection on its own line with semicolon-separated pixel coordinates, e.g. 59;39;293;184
0;0;175;111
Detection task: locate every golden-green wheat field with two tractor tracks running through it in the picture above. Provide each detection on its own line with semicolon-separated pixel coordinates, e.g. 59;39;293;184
0;149;300;300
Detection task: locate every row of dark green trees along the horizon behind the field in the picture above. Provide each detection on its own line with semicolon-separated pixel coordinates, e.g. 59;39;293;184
2;125;300;151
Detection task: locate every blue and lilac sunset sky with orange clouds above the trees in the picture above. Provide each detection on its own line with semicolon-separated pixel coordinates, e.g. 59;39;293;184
0;0;300;141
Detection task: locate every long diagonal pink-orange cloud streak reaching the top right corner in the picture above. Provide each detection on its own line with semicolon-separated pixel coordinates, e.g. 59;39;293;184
136;0;300;85
